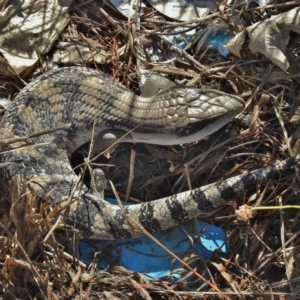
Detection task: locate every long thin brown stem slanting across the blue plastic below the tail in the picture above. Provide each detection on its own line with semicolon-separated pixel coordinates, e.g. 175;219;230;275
126;215;230;300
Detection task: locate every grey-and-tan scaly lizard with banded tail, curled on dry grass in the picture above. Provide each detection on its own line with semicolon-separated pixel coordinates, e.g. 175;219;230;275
0;67;299;239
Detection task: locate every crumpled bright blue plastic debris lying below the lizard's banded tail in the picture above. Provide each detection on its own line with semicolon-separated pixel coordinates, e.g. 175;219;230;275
79;199;227;281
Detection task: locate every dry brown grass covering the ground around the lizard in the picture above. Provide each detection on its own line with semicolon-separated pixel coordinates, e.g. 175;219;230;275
0;1;300;299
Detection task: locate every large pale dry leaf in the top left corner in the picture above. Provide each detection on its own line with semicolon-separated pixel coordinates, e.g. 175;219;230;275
0;0;72;75
